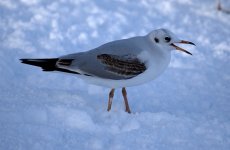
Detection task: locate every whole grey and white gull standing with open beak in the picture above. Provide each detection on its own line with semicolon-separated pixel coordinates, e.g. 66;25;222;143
20;29;195;113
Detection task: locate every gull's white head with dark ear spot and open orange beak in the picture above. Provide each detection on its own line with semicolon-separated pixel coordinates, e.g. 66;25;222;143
147;29;195;55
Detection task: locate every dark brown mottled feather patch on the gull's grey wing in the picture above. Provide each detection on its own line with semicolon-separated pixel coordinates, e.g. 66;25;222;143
97;54;146;78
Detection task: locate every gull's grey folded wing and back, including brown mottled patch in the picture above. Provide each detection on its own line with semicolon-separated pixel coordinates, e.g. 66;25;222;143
57;38;146;80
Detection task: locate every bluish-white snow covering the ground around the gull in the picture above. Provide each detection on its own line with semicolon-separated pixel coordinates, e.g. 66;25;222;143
0;0;230;150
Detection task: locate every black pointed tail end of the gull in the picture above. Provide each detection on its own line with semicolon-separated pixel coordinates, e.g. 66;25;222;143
20;58;58;71
